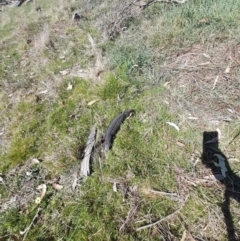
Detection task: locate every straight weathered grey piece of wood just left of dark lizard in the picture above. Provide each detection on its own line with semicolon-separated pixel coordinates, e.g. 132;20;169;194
80;124;97;177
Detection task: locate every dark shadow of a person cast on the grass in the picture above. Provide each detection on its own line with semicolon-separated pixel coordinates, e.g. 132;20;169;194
202;131;240;241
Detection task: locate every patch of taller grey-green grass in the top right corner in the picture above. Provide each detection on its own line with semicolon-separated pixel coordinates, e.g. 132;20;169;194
142;0;240;48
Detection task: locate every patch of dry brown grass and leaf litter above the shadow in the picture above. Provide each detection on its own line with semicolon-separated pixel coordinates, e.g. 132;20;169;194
163;43;240;121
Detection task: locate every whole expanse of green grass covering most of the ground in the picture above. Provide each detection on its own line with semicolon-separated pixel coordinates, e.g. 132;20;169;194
0;0;240;241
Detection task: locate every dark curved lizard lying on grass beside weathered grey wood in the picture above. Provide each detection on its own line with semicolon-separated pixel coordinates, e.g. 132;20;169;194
104;110;135;151
